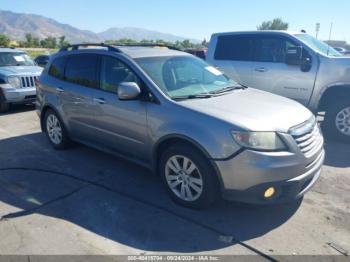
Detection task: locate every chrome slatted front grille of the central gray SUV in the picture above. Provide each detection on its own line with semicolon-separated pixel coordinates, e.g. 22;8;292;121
290;118;323;157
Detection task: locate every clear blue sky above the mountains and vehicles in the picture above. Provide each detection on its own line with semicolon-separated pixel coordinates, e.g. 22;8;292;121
0;0;350;42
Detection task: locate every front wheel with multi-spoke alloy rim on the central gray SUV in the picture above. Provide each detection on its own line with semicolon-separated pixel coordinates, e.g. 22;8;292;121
159;144;219;209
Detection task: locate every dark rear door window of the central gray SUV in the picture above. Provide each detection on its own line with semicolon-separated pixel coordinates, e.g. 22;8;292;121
65;54;99;88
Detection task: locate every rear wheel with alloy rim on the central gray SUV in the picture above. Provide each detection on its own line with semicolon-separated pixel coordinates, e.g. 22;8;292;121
44;110;71;150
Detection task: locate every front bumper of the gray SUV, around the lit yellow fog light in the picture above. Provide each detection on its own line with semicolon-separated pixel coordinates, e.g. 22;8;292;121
215;147;325;204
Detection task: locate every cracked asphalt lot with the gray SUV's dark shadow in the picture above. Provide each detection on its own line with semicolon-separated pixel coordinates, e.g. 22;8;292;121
0;106;350;258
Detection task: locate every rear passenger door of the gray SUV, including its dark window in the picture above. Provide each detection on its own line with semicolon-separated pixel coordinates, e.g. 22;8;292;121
58;53;99;143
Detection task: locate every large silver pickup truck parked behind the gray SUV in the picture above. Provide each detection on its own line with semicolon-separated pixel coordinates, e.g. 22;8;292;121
207;31;350;142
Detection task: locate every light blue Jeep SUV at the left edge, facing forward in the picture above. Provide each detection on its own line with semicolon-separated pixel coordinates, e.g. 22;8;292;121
0;48;42;112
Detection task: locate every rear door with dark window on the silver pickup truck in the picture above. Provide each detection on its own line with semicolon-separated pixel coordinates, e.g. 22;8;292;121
209;34;254;86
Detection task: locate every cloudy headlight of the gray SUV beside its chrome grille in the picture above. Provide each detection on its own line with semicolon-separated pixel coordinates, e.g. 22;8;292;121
232;131;286;151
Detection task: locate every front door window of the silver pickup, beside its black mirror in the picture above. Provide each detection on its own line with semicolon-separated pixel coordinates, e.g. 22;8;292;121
256;36;296;63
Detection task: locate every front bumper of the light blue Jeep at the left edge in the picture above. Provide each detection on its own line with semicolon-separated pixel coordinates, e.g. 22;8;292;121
0;84;36;103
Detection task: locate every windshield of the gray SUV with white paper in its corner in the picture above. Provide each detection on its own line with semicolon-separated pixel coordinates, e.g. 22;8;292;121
135;56;239;98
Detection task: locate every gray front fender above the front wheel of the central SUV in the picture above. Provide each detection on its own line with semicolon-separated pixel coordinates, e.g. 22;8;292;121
148;102;240;159
